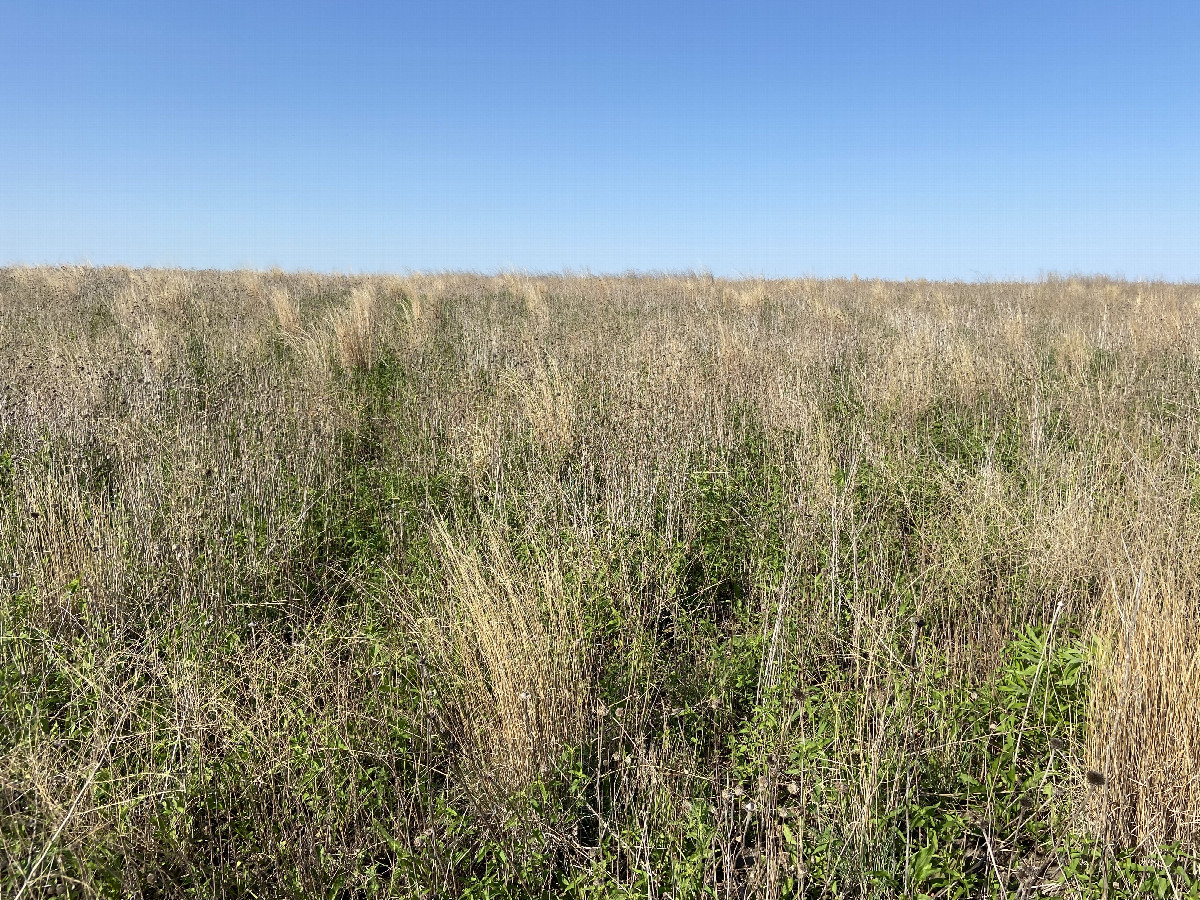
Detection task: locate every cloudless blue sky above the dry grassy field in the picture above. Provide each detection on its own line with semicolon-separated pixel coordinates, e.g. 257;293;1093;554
0;0;1200;280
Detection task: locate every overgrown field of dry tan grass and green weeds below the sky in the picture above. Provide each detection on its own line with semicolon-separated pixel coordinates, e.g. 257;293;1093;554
0;269;1200;900
